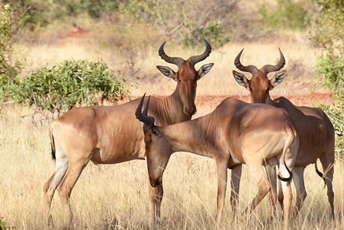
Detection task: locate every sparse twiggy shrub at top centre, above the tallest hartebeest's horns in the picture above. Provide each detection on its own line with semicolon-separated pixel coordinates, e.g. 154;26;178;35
118;0;234;47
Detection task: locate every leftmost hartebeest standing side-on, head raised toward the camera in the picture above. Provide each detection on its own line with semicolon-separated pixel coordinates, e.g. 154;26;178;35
44;40;214;226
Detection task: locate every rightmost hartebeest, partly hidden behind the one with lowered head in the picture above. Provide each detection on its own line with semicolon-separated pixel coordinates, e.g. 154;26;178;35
233;50;335;218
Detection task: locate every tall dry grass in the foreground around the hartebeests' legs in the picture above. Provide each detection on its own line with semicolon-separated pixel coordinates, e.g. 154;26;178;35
0;104;344;230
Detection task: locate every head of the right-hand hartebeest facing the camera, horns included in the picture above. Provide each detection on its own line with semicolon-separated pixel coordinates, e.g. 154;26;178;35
233;49;285;104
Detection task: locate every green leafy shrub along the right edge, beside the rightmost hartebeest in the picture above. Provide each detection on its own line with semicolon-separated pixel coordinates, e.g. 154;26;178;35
310;0;344;155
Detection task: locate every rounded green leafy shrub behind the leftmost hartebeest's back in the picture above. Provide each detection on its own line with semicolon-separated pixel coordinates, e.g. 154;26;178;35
16;60;129;119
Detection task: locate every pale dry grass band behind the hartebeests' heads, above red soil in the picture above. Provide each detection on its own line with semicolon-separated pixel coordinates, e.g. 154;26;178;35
14;27;325;99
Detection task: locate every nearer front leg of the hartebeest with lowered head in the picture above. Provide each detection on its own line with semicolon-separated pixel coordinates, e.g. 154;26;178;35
216;159;228;226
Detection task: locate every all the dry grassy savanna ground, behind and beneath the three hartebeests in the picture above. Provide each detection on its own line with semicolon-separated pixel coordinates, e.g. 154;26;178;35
0;2;344;229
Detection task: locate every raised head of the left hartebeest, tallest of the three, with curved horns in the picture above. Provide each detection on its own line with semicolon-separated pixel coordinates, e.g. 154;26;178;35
157;39;214;116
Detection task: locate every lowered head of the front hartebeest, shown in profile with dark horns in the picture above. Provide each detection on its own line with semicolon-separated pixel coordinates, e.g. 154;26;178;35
135;95;172;187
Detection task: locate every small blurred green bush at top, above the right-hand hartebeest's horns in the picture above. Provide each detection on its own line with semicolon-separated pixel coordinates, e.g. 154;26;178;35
258;0;309;29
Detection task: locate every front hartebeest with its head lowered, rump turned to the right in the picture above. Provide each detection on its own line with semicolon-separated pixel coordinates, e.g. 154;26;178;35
136;95;299;228
